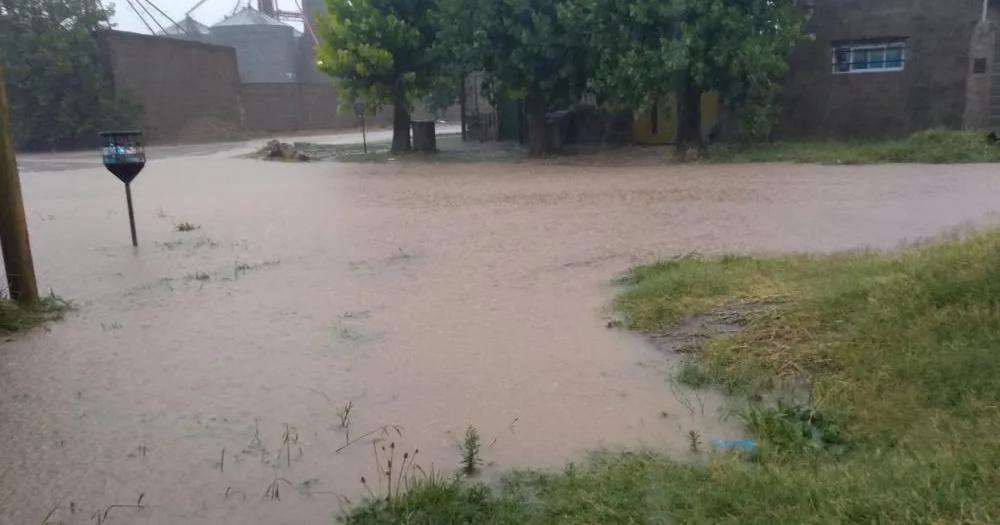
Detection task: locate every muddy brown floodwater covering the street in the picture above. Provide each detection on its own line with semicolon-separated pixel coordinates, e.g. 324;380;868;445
0;136;1000;524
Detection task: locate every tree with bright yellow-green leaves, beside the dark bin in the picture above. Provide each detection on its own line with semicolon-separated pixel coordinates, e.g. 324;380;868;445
316;0;436;153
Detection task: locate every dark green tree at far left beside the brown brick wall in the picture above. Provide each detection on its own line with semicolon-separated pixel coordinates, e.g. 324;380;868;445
0;0;136;149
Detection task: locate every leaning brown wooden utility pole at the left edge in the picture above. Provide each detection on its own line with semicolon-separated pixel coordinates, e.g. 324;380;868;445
0;64;38;304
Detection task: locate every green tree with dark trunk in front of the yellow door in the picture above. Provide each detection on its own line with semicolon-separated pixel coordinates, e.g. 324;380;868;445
575;0;803;149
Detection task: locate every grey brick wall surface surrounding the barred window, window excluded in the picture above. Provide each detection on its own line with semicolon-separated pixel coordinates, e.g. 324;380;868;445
777;0;982;138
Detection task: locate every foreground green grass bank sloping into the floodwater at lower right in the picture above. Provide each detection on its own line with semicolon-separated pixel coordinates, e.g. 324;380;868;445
340;231;1000;525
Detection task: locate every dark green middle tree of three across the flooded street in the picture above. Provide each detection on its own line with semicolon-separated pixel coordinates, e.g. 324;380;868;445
470;0;588;156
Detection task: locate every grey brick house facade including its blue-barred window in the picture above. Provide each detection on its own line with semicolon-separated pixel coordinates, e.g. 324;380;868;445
776;0;1000;139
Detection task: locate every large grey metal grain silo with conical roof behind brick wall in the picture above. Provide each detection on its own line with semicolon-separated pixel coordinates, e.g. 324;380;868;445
210;7;298;83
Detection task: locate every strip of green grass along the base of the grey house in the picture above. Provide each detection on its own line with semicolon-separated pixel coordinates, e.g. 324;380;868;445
705;129;1000;164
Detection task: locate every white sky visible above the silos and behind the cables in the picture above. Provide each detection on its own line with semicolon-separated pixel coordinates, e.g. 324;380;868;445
105;0;302;34
